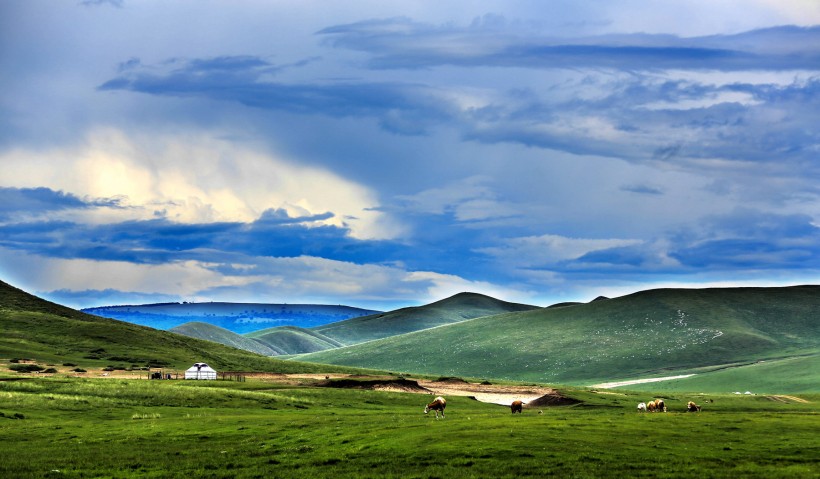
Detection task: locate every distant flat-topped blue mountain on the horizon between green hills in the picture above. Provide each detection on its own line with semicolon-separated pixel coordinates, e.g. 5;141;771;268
82;303;381;334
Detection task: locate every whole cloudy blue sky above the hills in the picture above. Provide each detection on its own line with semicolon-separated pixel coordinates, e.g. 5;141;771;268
0;0;820;310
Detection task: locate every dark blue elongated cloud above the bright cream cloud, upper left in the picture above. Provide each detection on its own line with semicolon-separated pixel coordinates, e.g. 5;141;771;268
99;56;450;135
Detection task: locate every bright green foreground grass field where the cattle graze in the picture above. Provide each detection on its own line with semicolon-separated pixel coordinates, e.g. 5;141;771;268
0;377;820;478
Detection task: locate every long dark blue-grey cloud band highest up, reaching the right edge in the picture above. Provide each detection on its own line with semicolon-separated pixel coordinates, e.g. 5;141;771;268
318;17;820;71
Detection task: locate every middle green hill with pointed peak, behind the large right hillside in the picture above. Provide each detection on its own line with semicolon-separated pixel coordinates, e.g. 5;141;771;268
313;293;539;345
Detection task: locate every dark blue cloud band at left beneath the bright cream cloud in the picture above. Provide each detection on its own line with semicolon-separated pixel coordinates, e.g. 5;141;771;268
0;210;410;264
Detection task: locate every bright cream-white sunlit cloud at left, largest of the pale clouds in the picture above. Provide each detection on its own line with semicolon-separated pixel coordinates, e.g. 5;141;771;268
0;129;400;238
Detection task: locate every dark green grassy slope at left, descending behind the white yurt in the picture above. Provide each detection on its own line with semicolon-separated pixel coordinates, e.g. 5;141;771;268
0;281;370;372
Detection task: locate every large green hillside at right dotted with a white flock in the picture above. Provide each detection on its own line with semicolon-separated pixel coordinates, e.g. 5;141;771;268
300;286;820;391
